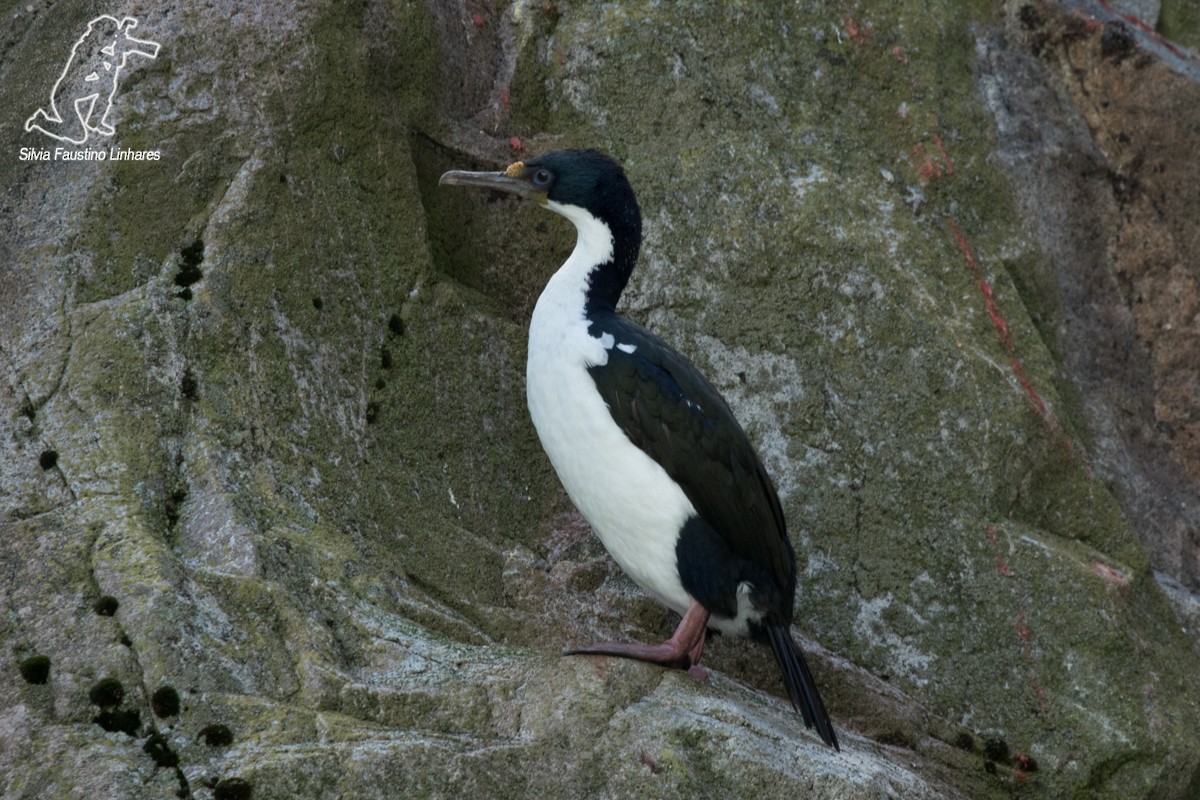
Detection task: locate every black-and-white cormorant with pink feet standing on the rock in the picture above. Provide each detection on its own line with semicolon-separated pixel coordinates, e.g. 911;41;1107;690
438;149;840;750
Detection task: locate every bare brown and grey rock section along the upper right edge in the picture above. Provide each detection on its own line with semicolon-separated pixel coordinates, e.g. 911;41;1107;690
980;4;1200;590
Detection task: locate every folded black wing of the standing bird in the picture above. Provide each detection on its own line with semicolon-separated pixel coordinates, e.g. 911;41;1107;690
588;314;796;624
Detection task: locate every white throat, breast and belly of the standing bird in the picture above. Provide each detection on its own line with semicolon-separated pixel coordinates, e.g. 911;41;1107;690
526;201;695;613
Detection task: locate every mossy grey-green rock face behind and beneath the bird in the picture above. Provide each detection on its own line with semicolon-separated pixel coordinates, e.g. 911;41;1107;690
0;1;1200;799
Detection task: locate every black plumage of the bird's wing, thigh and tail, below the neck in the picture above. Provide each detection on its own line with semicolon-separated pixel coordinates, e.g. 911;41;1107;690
588;313;839;750
